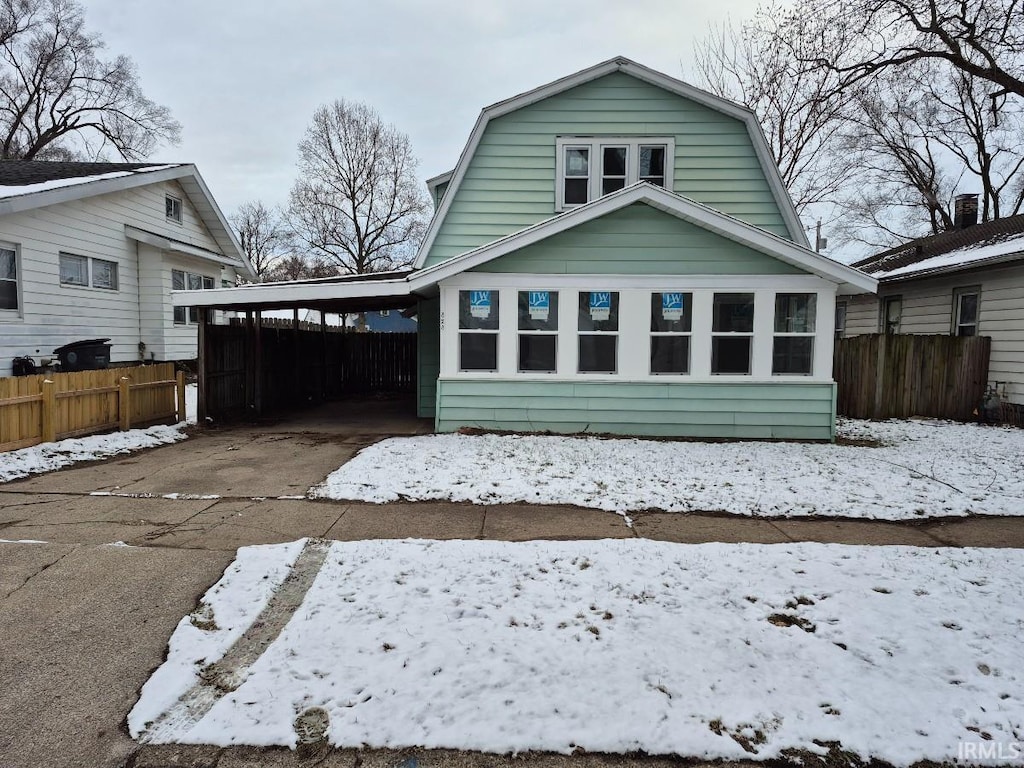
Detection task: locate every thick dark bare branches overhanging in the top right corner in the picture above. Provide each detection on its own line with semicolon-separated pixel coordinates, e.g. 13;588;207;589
780;0;1024;96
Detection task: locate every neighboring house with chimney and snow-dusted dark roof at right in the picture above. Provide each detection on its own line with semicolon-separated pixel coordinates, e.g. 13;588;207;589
836;195;1024;406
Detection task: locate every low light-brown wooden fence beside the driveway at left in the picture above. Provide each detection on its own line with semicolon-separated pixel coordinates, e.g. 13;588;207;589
0;362;185;452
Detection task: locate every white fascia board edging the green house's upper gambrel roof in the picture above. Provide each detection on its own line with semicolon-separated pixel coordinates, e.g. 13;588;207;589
413;56;809;269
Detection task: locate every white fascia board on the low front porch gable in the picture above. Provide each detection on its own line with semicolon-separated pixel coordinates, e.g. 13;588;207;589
410;181;878;293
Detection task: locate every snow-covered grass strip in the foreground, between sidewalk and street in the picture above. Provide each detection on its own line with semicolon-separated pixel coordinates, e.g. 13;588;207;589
128;540;1024;765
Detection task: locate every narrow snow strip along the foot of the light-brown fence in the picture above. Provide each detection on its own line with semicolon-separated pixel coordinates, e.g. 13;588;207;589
0;425;187;483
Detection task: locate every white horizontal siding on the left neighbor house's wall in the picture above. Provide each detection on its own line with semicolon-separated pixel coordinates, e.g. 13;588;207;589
0;182;233;376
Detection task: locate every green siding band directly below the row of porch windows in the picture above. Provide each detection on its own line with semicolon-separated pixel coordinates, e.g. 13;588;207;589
436;380;836;440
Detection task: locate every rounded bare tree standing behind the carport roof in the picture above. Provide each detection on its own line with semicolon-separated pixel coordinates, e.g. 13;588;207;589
289;100;430;273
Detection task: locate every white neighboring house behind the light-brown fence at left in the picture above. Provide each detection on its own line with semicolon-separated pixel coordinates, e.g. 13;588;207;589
0;160;254;376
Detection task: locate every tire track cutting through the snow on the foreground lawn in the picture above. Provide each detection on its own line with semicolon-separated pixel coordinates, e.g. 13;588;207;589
138;539;331;743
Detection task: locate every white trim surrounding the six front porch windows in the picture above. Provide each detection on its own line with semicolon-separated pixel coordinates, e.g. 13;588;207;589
440;272;837;384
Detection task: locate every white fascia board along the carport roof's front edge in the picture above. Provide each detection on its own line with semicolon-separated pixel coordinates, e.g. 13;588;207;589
171;280;412;307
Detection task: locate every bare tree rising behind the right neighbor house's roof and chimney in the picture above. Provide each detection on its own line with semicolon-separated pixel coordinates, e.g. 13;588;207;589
841;60;1024;248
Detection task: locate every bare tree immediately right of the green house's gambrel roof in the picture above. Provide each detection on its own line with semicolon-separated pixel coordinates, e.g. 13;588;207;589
695;5;854;213
